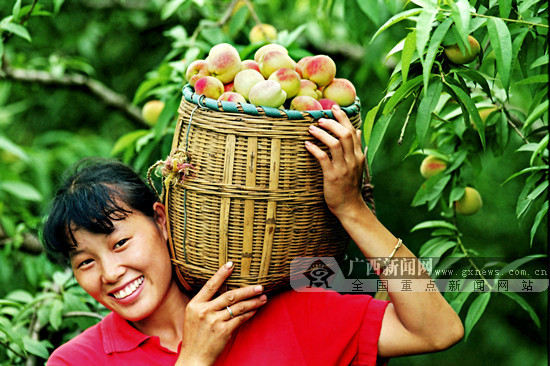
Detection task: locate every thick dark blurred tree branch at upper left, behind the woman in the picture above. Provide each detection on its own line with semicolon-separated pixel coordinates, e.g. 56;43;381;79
0;65;149;128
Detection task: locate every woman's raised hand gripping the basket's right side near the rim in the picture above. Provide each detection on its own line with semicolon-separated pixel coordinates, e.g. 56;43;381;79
305;106;365;218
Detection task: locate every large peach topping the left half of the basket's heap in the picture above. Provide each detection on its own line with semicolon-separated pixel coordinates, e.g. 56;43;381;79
206;43;241;84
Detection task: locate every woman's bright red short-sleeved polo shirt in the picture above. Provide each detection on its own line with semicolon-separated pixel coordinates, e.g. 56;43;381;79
48;291;388;366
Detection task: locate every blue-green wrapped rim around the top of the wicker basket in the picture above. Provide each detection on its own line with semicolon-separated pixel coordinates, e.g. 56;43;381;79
182;84;361;120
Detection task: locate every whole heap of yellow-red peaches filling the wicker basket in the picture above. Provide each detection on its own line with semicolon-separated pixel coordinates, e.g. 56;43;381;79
185;43;356;111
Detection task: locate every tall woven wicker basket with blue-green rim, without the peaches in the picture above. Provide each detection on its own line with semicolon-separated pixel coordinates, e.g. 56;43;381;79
157;86;361;291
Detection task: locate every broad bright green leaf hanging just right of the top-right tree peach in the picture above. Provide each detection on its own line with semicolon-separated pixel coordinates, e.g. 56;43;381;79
487;18;512;91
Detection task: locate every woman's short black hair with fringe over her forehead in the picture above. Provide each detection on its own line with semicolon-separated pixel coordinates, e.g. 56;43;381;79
43;158;157;258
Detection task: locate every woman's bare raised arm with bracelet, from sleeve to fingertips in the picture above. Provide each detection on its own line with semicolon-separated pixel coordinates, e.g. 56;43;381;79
306;108;464;357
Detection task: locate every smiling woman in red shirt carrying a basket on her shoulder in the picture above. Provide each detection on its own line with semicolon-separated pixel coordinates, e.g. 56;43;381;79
44;107;463;365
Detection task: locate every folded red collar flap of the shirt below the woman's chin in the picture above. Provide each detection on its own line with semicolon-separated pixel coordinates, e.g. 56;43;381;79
101;312;152;354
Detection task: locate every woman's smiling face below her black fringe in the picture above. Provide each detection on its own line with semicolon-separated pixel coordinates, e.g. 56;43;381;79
70;203;174;321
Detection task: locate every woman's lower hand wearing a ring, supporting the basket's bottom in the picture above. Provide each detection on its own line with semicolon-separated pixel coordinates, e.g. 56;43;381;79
176;262;267;365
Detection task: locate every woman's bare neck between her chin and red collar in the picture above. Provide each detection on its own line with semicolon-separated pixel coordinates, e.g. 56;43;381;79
130;280;190;351
